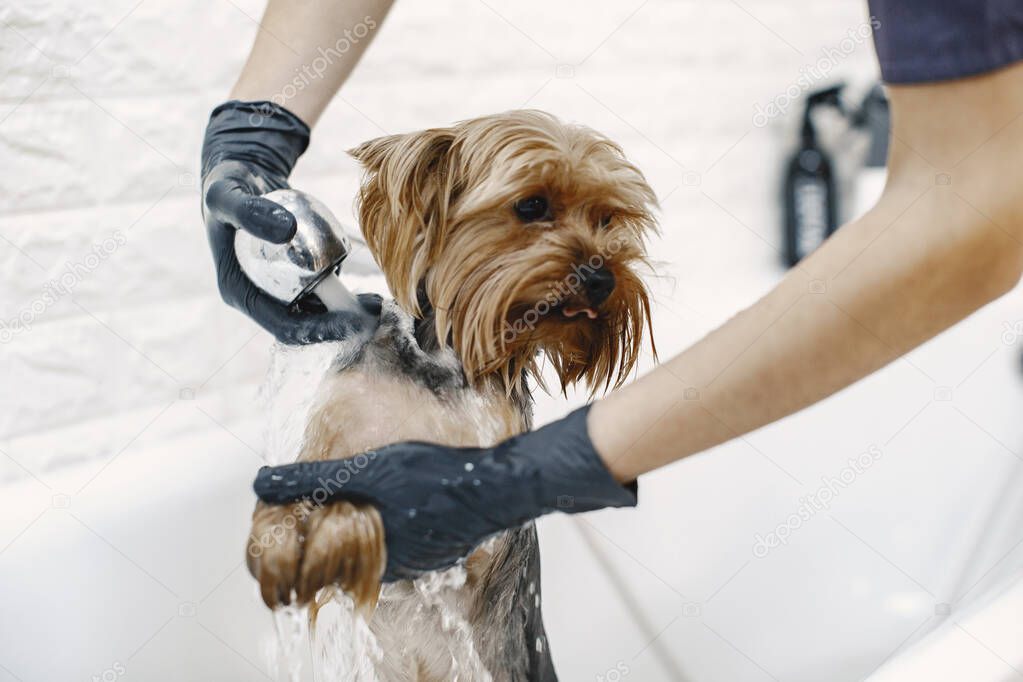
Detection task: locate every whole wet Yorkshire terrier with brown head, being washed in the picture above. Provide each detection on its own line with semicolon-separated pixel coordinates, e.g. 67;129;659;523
248;110;656;682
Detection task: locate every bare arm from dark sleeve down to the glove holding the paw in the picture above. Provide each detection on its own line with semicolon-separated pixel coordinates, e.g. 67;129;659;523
588;65;1023;481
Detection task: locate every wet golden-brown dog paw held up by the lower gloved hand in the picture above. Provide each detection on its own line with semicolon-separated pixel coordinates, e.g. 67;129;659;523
247;502;387;608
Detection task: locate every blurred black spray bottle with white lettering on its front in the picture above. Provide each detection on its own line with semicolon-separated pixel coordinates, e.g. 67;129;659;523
784;85;843;266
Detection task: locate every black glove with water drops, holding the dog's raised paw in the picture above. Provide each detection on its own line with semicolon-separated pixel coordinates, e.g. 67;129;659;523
254;406;636;582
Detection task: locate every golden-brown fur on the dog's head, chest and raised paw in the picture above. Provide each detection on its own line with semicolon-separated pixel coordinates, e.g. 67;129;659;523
249;111;656;679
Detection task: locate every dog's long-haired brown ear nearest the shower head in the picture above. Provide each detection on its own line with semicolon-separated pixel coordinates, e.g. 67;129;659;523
349;129;457;315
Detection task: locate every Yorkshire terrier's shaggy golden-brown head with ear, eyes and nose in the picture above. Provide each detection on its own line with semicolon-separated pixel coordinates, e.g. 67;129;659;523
352;111;656;391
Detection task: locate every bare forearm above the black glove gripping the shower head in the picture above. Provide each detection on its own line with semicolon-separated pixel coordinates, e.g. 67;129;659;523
231;0;394;127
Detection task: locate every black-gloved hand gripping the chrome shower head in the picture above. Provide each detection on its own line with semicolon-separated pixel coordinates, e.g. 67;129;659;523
203;100;379;344
